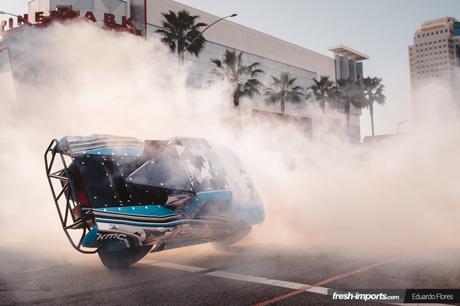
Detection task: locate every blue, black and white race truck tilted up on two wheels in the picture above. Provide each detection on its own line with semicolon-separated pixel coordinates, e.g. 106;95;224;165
45;135;265;269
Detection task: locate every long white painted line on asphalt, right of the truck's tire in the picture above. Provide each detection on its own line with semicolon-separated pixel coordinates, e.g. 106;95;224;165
140;259;449;306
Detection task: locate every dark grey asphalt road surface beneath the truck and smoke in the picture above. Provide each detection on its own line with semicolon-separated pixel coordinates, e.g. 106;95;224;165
0;241;460;305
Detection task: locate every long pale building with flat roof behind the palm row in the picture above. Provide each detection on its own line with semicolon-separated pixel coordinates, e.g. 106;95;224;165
142;0;368;142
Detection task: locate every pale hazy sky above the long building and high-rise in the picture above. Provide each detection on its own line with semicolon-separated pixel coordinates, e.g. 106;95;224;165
0;0;460;135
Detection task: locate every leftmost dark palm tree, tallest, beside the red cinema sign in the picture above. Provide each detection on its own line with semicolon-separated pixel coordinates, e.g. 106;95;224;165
156;10;207;62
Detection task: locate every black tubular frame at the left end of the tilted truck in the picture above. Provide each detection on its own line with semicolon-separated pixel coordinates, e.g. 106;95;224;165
44;139;97;254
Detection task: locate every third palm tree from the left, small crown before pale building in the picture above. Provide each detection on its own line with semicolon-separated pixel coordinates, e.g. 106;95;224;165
265;72;304;114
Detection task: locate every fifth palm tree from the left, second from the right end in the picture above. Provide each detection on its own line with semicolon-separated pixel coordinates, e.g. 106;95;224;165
335;79;365;134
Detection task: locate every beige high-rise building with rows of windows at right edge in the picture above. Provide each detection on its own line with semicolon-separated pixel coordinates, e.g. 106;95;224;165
409;17;460;94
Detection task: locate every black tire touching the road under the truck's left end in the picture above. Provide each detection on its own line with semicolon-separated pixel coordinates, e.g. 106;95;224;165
97;245;152;270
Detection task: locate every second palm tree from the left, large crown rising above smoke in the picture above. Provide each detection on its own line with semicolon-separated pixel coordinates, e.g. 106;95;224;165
211;50;264;107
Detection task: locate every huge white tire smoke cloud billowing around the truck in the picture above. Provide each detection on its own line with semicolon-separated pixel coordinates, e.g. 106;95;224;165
0;22;460;260
